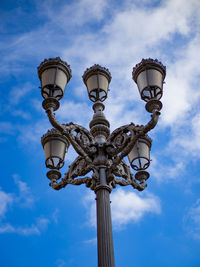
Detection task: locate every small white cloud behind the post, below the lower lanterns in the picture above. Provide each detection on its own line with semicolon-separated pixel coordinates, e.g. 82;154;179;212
84;188;161;229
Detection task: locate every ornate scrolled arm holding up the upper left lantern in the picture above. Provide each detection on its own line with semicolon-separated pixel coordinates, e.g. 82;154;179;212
46;107;96;162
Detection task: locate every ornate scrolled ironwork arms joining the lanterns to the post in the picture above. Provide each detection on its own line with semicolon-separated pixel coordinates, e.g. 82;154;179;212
42;99;160;191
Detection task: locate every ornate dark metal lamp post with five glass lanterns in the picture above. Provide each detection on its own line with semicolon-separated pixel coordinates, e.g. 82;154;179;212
38;57;166;267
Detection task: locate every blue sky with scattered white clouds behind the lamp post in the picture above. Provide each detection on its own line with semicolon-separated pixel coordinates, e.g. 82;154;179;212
0;0;200;267
